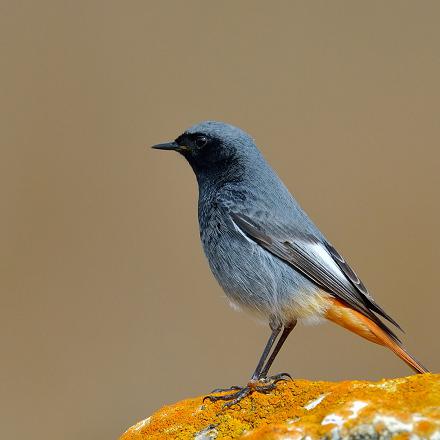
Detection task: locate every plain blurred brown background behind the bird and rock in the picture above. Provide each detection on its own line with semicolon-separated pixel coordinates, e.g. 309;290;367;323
0;0;440;440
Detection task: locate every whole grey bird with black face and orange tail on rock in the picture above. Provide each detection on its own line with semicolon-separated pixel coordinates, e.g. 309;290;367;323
152;121;429;407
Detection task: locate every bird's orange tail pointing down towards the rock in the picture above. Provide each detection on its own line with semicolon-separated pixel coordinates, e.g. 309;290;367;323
325;298;429;373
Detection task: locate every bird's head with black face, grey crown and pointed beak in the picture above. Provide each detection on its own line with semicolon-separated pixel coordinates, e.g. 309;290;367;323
153;121;259;177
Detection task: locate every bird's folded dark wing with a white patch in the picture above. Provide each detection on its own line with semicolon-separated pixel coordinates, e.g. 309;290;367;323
230;211;400;342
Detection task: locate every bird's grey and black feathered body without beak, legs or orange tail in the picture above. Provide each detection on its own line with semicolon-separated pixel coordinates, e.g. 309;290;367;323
177;121;395;334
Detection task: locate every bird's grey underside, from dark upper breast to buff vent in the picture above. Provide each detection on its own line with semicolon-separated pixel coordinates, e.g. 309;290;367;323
199;198;324;321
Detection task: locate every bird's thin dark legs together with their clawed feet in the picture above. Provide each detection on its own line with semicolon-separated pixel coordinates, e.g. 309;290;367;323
203;321;296;407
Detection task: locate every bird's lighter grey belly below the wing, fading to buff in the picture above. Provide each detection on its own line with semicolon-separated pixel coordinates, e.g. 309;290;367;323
202;230;329;322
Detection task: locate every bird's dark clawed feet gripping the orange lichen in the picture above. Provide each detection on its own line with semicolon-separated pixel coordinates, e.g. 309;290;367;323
203;373;292;408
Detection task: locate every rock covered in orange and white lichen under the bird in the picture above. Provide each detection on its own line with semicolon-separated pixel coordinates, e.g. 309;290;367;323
120;374;440;440
